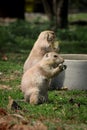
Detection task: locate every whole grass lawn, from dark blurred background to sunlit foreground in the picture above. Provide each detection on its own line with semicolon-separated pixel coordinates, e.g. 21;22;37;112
0;13;87;130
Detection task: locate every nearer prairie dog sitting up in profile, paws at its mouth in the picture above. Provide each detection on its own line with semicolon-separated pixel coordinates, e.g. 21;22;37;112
21;52;65;104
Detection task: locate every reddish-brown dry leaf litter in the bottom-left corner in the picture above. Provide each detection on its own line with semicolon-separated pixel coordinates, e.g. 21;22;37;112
0;107;47;130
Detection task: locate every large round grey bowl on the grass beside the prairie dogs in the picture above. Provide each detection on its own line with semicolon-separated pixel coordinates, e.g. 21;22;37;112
51;54;87;90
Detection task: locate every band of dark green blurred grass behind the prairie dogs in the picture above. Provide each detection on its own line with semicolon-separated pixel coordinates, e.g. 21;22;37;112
0;21;87;53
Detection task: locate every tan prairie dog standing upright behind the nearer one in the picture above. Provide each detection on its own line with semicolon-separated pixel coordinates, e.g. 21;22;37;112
23;30;58;72
